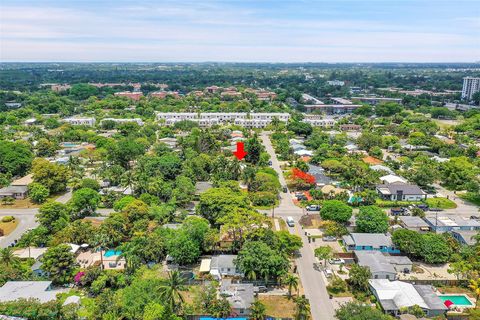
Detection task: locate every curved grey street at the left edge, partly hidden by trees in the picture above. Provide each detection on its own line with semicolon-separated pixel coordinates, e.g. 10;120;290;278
0;190;72;248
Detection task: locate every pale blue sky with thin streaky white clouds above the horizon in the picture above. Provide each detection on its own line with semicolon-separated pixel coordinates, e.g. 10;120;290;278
0;0;480;62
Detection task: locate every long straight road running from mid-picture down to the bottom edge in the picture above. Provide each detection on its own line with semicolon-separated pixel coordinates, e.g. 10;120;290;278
261;132;335;320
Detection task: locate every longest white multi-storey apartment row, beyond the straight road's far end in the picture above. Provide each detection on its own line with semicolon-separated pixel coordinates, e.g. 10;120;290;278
157;112;290;128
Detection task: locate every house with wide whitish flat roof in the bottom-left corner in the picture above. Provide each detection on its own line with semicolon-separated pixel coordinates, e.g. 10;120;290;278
0;281;64;303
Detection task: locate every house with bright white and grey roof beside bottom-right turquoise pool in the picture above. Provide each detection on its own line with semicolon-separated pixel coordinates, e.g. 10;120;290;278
368;279;448;317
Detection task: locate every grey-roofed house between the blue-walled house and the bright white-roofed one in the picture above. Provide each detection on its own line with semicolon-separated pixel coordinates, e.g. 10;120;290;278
354;250;412;280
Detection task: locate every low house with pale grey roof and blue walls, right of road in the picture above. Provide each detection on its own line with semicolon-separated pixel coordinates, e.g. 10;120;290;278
342;233;400;253
